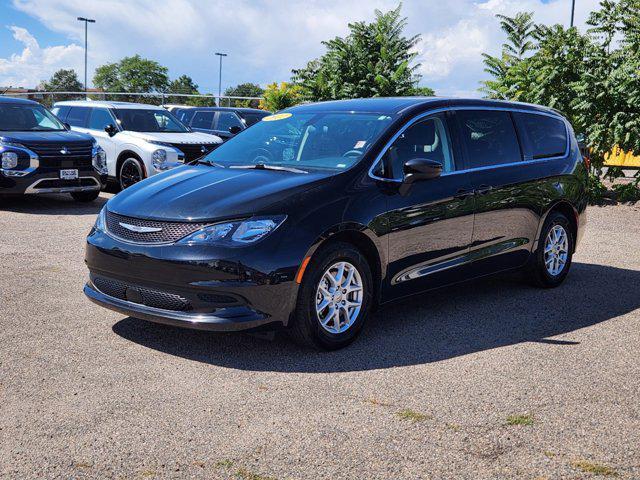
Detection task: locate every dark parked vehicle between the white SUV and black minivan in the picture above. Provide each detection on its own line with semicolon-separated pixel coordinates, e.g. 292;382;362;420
175;107;271;140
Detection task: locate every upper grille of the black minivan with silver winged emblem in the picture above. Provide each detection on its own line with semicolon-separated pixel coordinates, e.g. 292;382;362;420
107;210;209;244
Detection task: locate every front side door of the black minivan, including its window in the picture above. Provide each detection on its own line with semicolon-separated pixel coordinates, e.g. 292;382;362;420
383;113;474;299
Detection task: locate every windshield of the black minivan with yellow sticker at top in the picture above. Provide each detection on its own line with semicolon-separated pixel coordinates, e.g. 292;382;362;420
206;112;391;170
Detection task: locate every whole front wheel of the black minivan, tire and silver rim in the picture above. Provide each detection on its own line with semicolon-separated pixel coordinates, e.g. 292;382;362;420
289;243;373;350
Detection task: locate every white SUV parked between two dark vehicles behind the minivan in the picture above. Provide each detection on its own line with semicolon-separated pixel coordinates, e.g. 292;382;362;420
52;101;222;189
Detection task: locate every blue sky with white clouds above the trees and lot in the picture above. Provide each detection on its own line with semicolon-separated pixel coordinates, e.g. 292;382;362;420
0;0;597;96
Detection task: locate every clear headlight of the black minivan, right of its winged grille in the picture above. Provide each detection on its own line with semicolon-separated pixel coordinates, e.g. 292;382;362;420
180;215;287;246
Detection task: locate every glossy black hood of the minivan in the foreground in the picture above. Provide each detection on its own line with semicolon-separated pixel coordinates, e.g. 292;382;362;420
108;165;332;221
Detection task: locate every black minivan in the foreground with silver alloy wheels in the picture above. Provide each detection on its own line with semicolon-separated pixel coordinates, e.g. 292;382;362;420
84;97;587;349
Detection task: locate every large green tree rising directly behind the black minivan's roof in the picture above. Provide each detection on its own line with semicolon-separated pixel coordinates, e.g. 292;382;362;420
293;5;432;101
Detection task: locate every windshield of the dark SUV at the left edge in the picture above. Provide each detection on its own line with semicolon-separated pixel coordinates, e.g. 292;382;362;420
0;103;65;132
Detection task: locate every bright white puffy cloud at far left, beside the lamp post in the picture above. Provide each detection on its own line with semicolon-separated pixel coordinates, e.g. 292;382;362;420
0;26;83;87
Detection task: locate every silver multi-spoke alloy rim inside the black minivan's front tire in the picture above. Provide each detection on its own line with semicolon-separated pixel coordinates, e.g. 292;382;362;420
316;262;364;334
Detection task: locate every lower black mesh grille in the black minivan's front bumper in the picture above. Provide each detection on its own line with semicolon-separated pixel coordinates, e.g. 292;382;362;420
91;277;192;312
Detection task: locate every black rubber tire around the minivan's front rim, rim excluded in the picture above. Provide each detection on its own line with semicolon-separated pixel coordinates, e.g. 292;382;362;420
294;243;373;350
